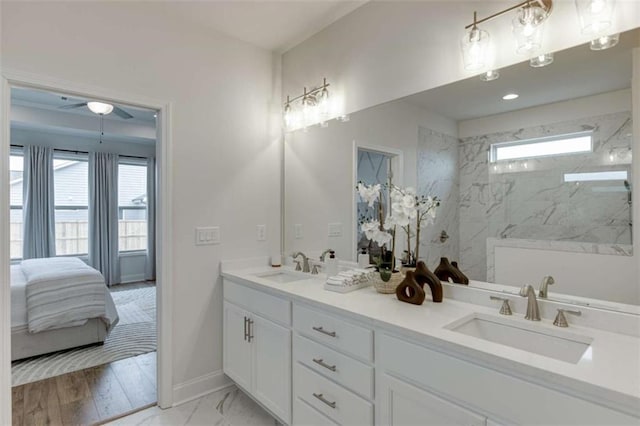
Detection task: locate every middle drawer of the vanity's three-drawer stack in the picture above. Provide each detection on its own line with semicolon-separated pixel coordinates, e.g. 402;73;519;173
293;334;373;398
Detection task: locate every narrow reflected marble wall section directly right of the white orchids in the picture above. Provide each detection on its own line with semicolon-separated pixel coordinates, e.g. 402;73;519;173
416;127;460;270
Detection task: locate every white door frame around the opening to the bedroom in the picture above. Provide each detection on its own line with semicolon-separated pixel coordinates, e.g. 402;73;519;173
0;69;173;424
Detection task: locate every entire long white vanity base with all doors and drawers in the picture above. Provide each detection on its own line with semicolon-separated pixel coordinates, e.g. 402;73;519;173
223;277;640;426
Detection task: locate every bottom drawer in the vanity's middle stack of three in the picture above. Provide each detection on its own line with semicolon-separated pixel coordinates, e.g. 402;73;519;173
293;363;373;426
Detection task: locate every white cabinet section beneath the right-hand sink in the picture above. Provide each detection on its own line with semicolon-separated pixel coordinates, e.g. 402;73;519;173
376;333;639;426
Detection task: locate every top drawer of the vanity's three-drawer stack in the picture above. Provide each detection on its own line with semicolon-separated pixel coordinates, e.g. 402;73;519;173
293;305;373;361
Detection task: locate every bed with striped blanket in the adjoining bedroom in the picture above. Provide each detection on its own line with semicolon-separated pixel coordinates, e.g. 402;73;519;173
11;258;118;361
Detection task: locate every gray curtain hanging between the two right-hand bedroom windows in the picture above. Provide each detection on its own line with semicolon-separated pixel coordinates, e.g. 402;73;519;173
89;152;120;285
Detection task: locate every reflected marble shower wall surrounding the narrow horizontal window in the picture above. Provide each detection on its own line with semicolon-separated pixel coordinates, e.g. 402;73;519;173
459;112;632;280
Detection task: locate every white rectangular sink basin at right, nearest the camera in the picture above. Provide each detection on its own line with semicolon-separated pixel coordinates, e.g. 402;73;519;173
444;313;593;364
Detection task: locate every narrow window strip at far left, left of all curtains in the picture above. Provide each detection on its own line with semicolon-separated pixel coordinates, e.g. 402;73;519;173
9;154;24;260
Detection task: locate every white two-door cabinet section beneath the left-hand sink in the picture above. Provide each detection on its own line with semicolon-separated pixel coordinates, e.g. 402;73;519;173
223;280;291;424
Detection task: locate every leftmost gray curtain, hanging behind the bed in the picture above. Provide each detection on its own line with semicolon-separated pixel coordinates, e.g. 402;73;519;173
22;146;56;259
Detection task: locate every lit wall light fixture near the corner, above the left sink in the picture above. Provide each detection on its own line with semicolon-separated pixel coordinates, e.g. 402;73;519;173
283;78;331;131
